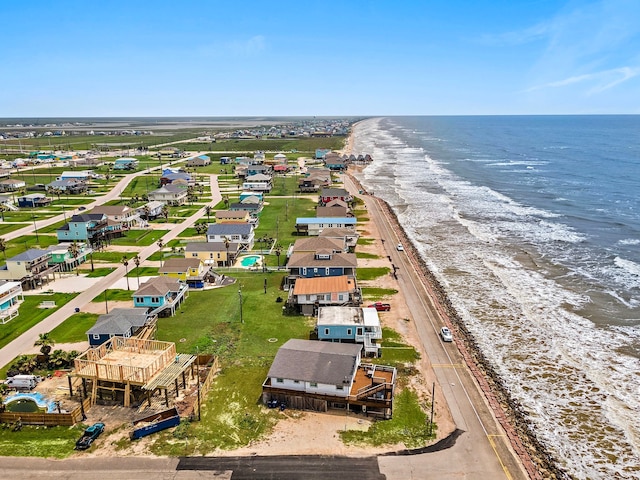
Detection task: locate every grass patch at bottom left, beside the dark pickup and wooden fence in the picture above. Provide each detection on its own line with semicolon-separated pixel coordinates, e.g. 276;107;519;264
0;424;85;458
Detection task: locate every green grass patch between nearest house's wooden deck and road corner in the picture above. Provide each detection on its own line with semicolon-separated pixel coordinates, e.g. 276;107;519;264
340;388;435;448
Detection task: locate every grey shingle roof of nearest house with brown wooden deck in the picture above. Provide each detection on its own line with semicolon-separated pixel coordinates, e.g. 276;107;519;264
268;339;362;385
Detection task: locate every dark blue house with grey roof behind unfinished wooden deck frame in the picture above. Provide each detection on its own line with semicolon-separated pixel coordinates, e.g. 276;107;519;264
87;308;158;348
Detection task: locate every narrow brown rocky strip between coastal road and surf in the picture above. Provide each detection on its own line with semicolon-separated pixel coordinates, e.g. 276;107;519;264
342;124;568;479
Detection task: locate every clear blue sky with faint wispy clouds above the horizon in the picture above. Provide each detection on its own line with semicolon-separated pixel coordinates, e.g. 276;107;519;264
0;0;640;117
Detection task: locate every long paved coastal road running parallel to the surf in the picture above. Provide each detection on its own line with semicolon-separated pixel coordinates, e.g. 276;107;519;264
344;175;530;480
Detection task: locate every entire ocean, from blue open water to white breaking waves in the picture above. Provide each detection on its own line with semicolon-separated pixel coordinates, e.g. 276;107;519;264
353;116;640;479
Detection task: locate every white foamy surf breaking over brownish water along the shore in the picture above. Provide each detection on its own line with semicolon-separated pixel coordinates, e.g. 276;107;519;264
350;117;640;478
